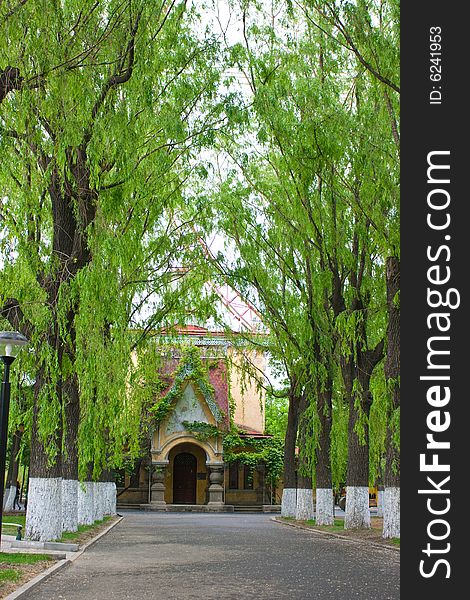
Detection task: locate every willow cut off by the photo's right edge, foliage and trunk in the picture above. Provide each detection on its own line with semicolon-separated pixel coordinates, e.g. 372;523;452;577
299;0;400;537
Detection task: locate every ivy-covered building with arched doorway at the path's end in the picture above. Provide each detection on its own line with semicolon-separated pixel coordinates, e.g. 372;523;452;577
117;326;278;510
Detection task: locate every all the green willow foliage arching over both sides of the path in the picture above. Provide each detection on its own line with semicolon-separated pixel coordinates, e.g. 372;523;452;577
0;0;400;506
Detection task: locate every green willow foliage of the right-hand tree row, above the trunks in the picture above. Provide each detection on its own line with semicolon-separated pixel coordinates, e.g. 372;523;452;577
204;1;399;494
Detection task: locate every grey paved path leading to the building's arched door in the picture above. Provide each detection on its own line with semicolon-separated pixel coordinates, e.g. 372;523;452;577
22;511;400;600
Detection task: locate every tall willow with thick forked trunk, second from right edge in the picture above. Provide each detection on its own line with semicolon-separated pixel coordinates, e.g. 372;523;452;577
199;2;396;527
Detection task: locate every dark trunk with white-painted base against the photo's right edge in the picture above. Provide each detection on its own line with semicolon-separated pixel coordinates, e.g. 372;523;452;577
382;256;400;538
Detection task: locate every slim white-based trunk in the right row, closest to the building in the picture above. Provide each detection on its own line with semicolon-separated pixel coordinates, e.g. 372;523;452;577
281;379;299;517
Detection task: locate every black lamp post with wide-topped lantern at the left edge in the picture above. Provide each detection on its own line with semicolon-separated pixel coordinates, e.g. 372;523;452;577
0;331;28;547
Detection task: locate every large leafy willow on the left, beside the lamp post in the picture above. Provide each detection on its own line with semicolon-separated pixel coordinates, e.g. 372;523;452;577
0;0;224;540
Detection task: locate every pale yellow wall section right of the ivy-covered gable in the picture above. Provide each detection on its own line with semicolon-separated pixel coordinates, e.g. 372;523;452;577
229;348;266;432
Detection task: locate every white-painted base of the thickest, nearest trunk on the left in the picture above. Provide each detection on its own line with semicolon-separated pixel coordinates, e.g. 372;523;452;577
25;477;62;542
